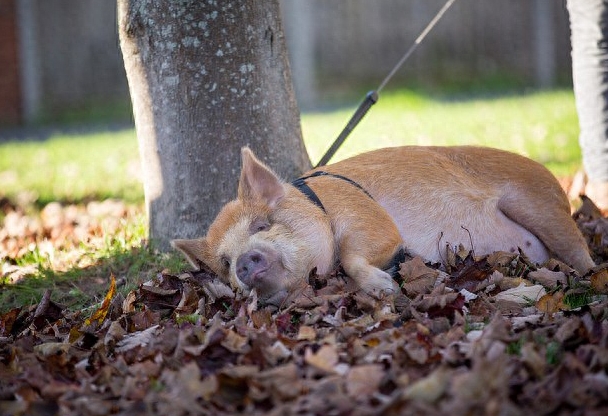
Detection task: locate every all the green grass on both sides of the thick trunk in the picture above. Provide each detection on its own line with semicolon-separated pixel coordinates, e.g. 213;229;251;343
0;90;580;311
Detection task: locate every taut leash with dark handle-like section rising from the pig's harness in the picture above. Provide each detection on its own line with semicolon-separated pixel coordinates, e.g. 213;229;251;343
315;0;455;168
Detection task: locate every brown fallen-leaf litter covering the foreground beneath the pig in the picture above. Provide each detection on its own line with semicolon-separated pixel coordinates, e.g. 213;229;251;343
0;197;608;415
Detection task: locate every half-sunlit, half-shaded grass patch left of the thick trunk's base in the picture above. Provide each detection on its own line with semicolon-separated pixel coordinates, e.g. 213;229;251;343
0;209;187;311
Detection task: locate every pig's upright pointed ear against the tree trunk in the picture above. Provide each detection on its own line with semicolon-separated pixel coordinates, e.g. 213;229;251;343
238;147;285;208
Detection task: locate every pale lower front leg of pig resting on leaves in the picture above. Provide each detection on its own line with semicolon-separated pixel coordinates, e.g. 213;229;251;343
340;253;399;298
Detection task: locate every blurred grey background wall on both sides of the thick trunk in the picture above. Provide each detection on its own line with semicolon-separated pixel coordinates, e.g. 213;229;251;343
0;0;570;125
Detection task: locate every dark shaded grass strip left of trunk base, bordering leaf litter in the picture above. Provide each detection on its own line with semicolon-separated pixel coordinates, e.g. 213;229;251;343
0;246;188;313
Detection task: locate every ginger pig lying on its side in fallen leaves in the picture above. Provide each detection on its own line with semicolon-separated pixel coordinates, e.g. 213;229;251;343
172;146;595;305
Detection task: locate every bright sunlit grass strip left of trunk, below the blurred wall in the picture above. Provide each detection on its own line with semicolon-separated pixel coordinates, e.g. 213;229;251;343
0;129;143;206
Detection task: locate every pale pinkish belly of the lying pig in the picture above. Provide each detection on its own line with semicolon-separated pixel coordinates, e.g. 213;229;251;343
389;202;548;263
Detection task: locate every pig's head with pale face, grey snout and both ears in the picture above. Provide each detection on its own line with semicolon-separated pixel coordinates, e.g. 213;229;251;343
172;148;335;305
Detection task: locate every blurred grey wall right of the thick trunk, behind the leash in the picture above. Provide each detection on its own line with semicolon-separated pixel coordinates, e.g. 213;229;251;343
283;0;571;107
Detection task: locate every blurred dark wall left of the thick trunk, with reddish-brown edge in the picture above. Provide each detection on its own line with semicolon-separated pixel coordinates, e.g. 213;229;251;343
0;0;128;124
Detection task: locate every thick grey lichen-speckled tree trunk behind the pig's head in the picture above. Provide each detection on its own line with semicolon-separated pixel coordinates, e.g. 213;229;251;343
118;0;310;250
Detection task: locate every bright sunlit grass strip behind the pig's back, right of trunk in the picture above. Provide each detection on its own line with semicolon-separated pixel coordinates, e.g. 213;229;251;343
302;90;581;176
